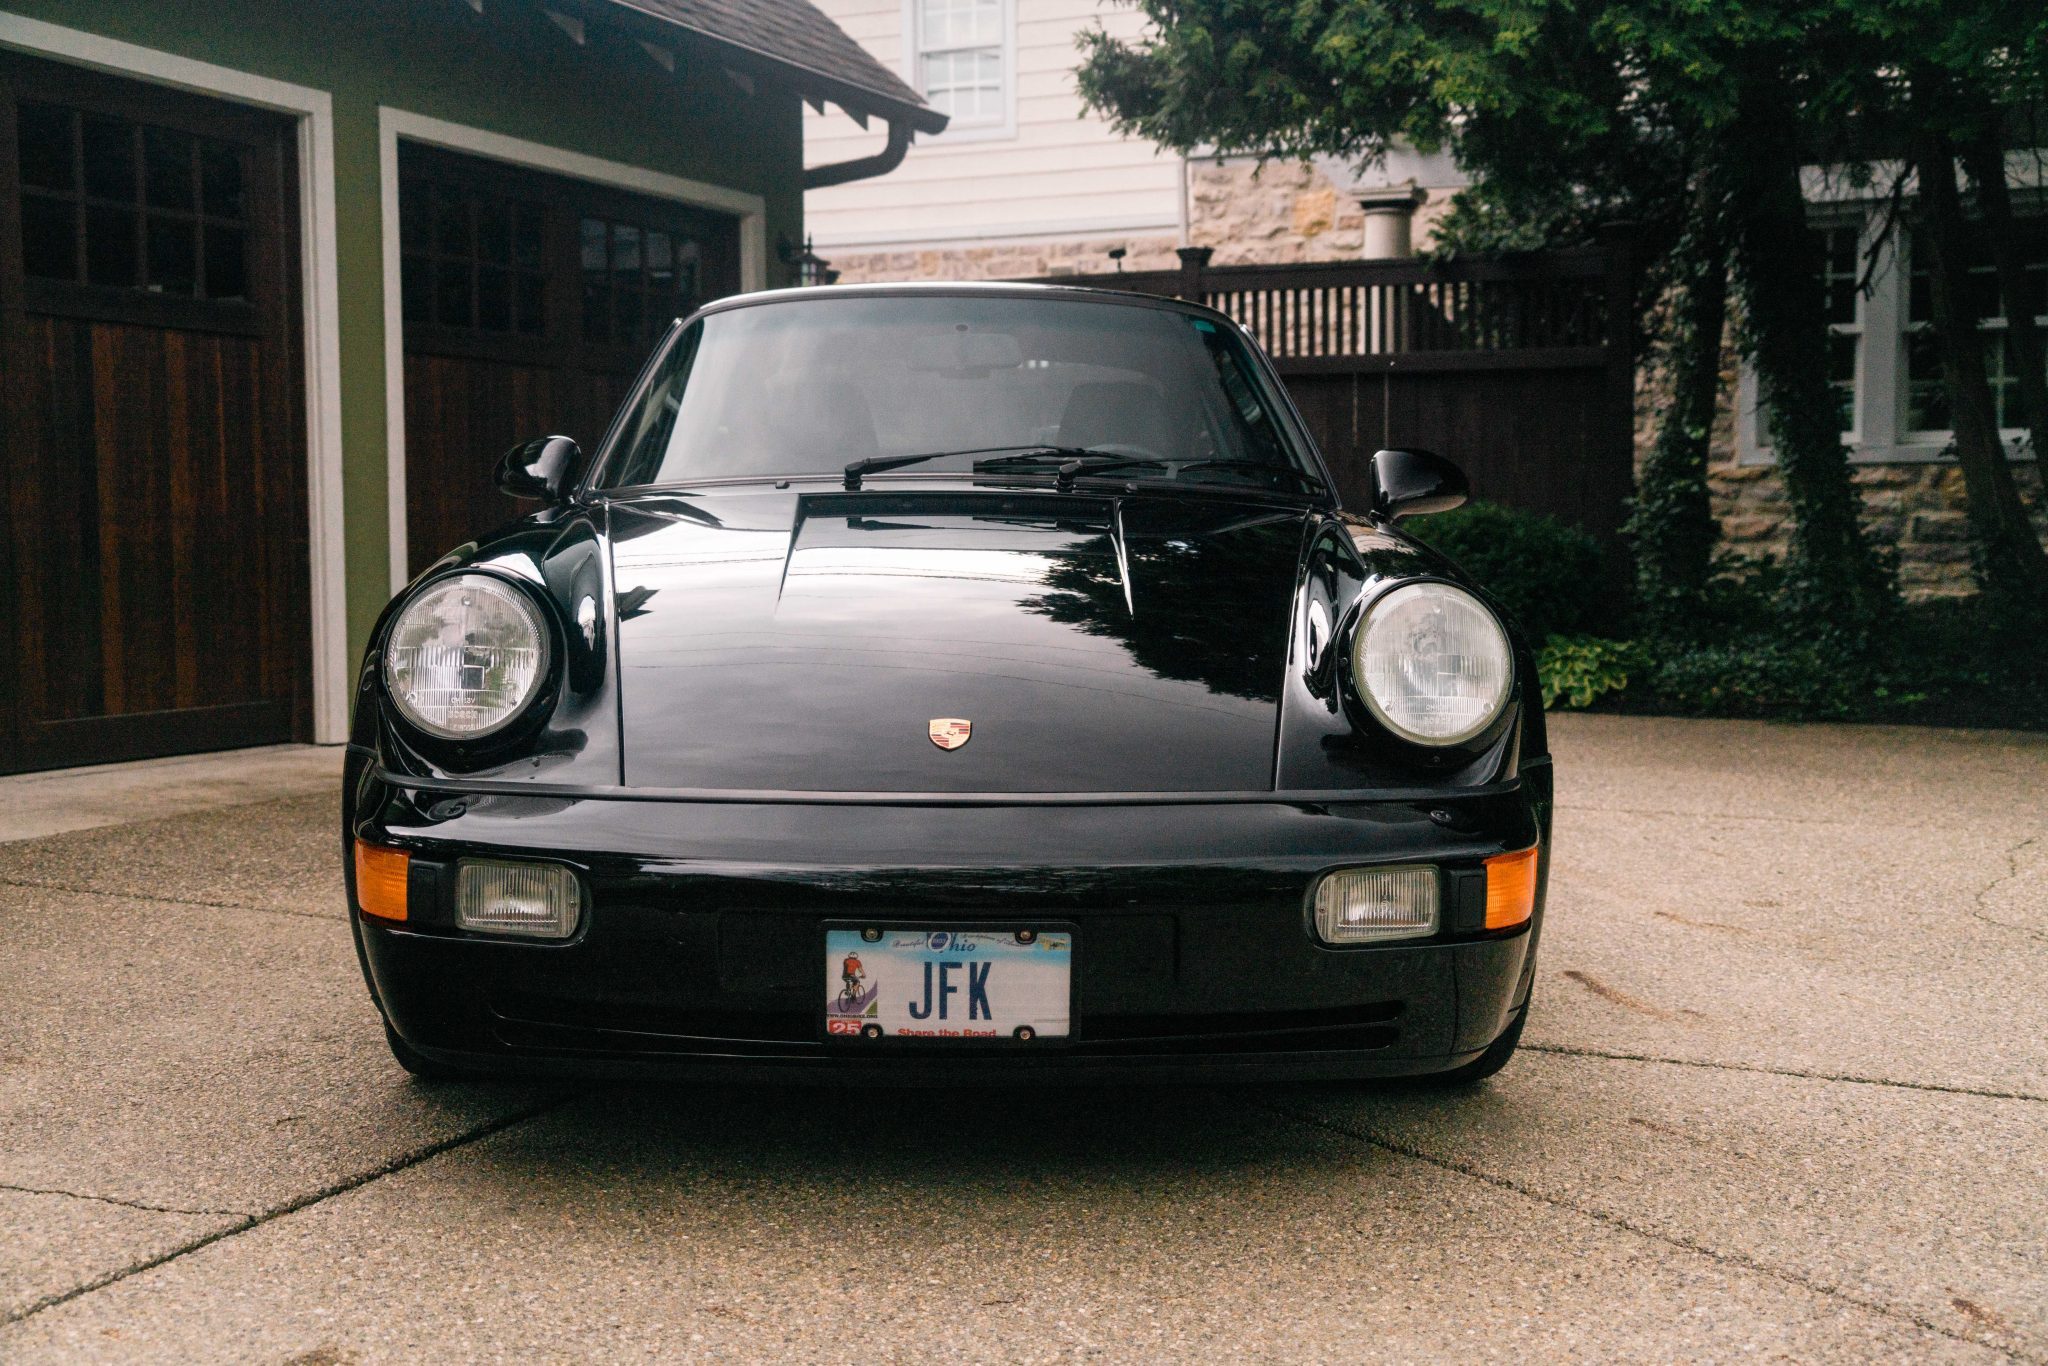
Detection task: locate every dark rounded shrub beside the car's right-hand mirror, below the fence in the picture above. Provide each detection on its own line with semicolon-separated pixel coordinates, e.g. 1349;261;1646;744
1401;502;1610;643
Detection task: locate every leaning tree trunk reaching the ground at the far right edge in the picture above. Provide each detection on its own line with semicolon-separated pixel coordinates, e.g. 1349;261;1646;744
1913;131;2048;623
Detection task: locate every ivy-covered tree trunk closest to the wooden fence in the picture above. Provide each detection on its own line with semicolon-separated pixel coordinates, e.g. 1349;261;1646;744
1626;186;1729;633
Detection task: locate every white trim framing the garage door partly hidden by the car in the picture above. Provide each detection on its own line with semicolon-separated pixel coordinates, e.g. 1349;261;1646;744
377;104;768;594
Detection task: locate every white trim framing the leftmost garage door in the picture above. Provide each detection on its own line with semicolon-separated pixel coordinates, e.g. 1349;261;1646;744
0;10;352;743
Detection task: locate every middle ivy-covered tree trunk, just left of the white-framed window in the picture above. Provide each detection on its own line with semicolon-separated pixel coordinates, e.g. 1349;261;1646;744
1718;88;1896;645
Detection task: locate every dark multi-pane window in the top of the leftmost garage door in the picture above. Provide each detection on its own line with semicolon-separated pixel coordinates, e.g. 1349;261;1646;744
16;100;250;301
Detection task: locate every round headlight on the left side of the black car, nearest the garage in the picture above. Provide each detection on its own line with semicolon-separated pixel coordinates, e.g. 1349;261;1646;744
385;573;547;739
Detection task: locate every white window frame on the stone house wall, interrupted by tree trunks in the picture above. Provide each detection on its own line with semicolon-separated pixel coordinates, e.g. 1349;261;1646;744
1735;150;2048;465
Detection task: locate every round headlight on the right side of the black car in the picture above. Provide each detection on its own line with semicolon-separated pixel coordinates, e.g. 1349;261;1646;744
1352;584;1513;745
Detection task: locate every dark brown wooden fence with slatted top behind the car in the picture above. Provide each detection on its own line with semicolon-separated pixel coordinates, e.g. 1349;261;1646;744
1019;229;1634;541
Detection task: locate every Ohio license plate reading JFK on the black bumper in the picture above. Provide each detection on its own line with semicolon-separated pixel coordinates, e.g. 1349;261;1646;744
825;926;1073;1042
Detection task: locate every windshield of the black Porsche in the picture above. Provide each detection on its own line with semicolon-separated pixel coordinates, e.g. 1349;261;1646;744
602;295;1321;489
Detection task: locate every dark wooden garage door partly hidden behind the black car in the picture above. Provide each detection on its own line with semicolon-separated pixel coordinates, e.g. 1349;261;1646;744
399;143;739;573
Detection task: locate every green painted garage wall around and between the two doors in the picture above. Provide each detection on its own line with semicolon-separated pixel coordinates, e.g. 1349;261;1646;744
4;0;803;670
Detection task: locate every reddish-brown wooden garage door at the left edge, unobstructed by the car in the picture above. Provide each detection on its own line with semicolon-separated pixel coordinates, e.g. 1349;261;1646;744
0;55;311;772
